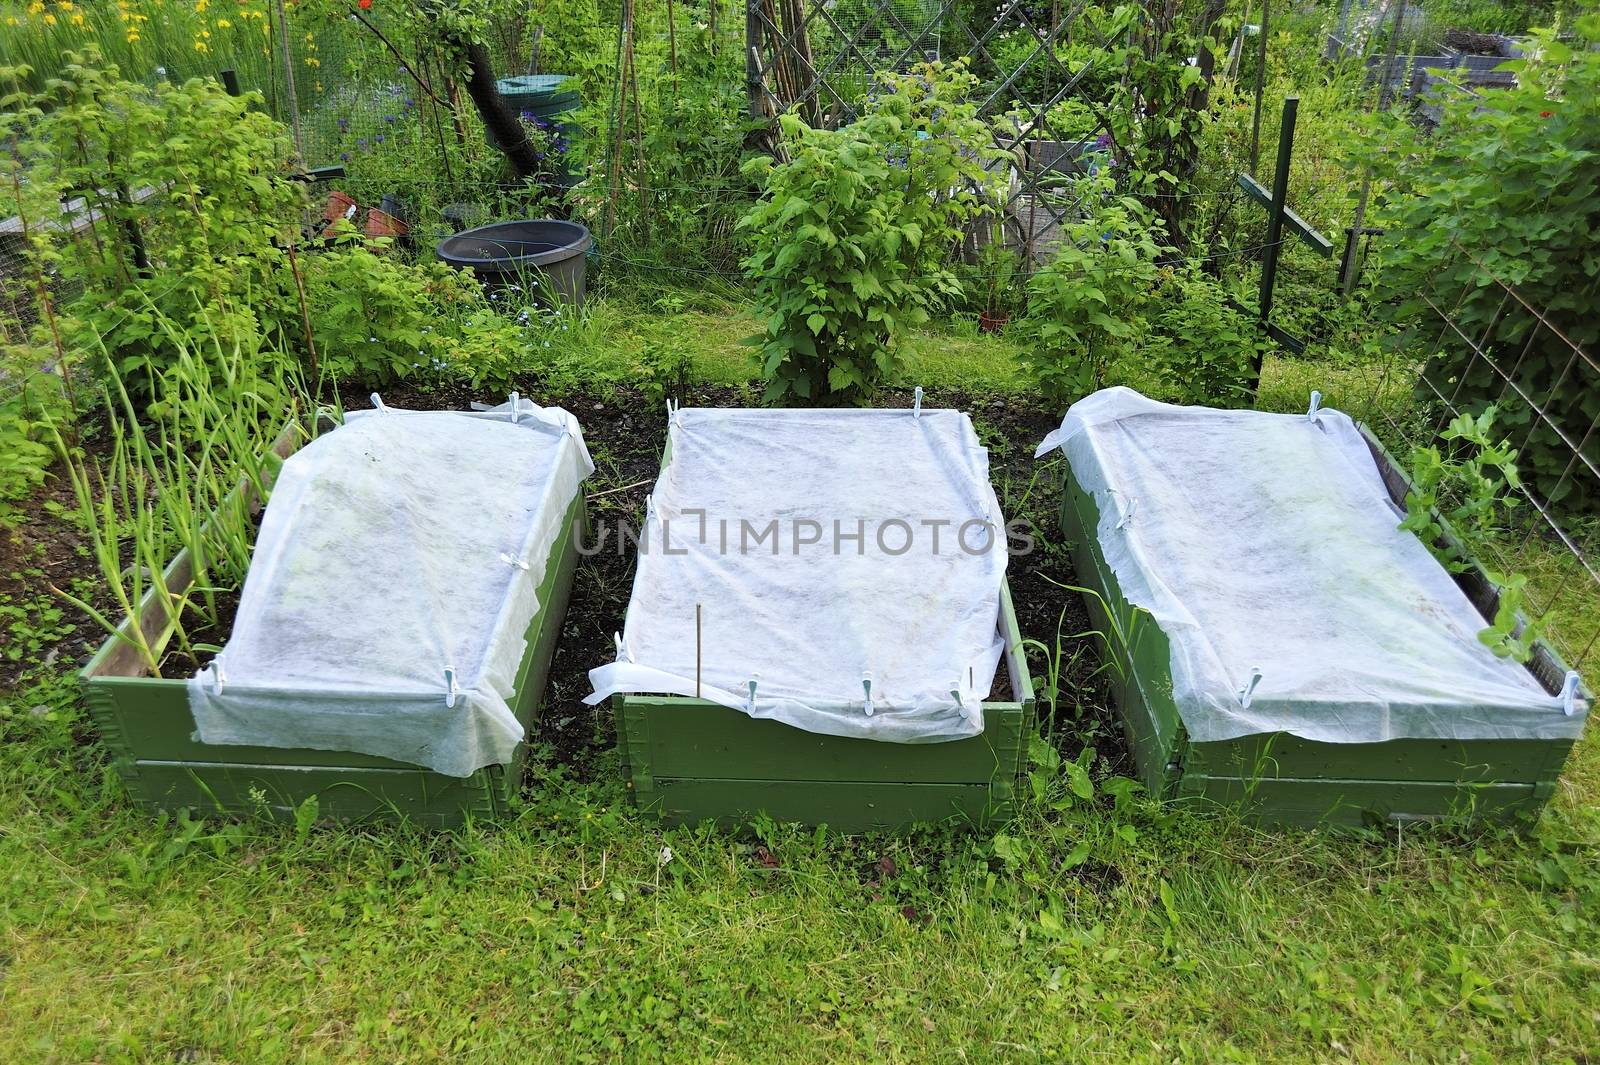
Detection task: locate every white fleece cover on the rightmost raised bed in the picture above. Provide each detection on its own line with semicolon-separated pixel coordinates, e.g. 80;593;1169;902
1038;389;1587;744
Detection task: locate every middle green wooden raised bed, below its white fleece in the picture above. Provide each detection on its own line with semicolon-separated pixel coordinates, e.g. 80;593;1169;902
611;587;1034;833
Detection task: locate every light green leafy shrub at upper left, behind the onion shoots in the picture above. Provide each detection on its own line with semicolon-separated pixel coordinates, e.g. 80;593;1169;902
0;51;304;392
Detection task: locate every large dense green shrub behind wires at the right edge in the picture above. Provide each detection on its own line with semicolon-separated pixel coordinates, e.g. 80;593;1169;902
1371;14;1600;510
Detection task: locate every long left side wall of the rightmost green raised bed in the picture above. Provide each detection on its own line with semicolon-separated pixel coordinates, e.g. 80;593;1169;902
1061;467;1184;796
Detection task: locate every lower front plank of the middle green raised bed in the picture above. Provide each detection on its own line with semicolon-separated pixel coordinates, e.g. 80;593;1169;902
646;779;1011;833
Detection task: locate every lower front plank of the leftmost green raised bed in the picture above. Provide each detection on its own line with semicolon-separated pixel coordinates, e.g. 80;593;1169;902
133;761;502;828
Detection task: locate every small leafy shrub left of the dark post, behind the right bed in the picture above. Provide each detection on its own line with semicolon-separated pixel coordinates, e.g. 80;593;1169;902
1018;179;1163;406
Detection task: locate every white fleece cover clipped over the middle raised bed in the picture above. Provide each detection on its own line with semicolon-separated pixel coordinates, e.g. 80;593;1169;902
587;408;1006;744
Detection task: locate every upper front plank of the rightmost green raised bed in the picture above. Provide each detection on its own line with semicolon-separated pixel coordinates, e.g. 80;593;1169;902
1184;732;1573;784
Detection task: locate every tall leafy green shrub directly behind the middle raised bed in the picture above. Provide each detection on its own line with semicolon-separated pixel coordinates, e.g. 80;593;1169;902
739;64;997;403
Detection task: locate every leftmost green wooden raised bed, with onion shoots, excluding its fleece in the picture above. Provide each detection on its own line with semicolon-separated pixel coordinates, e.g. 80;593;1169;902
80;425;587;828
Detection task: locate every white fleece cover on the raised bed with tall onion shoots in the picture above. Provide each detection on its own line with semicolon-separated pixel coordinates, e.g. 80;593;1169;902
189;397;594;777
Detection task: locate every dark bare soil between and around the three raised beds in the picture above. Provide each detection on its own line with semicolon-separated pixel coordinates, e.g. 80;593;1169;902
0;387;1131;777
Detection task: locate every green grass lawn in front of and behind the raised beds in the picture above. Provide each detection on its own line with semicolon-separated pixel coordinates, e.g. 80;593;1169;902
0;305;1600;1063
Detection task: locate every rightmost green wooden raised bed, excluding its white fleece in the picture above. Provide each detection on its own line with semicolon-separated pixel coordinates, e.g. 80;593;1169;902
1061;427;1589;827
